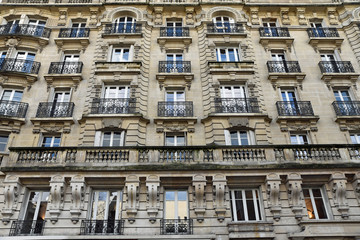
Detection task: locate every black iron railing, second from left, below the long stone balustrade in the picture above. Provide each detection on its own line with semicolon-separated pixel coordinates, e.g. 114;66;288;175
80;220;124;235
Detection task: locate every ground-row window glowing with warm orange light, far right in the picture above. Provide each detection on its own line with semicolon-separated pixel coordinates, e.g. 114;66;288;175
303;188;329;219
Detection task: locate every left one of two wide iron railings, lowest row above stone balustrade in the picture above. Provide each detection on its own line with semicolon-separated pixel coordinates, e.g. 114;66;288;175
91;98;136;114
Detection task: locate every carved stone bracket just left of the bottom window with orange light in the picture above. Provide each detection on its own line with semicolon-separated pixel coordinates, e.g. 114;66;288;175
286;173;303;220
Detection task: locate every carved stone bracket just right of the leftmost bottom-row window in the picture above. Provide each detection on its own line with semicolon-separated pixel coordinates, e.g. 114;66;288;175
49;175;65;224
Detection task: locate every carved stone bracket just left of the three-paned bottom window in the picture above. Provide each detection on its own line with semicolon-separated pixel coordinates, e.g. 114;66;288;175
213;174;227;222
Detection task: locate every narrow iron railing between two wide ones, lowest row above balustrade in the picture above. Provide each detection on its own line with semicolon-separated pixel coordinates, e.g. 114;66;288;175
158;101;193;117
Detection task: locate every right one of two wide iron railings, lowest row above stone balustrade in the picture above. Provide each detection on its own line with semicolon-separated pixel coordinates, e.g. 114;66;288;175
215;98;260;113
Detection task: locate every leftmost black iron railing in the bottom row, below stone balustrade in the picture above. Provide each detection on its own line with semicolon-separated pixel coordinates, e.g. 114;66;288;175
9;220;45;236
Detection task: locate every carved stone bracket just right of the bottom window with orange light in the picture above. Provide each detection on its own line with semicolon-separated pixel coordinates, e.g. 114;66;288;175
329;173;349;219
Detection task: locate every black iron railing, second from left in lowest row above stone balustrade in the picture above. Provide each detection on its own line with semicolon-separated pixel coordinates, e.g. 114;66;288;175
36;102;75;118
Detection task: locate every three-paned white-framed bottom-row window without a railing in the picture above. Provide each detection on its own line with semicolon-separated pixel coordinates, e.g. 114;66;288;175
230;189;262;222
